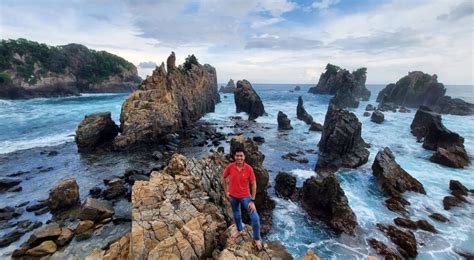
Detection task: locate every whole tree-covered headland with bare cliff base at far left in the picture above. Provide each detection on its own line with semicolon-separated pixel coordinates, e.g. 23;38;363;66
0;39;141;99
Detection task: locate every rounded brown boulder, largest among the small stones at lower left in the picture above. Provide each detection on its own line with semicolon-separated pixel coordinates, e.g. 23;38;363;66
48;178;79;210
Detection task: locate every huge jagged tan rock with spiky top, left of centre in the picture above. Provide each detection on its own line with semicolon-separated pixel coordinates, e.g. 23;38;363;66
114;54;220;149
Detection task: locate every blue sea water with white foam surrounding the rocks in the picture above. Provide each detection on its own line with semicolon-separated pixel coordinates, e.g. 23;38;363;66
0;84;474;259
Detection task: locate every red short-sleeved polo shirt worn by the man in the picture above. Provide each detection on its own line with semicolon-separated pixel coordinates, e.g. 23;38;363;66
224;162;255;198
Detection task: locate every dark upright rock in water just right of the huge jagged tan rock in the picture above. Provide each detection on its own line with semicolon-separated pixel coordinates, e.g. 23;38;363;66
234;79;265;120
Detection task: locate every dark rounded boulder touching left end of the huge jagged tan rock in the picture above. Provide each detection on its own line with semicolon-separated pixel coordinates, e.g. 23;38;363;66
74;112;119;152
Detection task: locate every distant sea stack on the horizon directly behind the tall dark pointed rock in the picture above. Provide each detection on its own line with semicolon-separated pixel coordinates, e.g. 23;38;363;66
308;63;370;101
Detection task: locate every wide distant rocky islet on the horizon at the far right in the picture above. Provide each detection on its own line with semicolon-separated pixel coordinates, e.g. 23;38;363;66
377;71;474;115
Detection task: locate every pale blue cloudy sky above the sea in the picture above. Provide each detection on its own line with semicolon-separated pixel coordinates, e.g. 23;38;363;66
0;0;474;85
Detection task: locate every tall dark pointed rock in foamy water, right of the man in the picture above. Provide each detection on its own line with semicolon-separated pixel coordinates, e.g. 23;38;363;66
316;104;369;173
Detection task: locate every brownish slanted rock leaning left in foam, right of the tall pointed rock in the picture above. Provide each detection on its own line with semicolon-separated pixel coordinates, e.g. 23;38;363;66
372;147;426;211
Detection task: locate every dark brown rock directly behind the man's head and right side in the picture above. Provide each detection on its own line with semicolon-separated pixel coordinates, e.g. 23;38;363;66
230;135;275;234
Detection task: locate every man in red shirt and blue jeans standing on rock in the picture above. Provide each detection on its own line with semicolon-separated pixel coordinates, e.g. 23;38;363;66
222;146;262;250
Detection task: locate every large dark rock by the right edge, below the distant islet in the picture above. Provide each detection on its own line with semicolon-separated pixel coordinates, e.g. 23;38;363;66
410;106;470;168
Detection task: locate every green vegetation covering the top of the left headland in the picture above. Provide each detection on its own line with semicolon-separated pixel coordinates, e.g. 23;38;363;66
0;38;140;84
